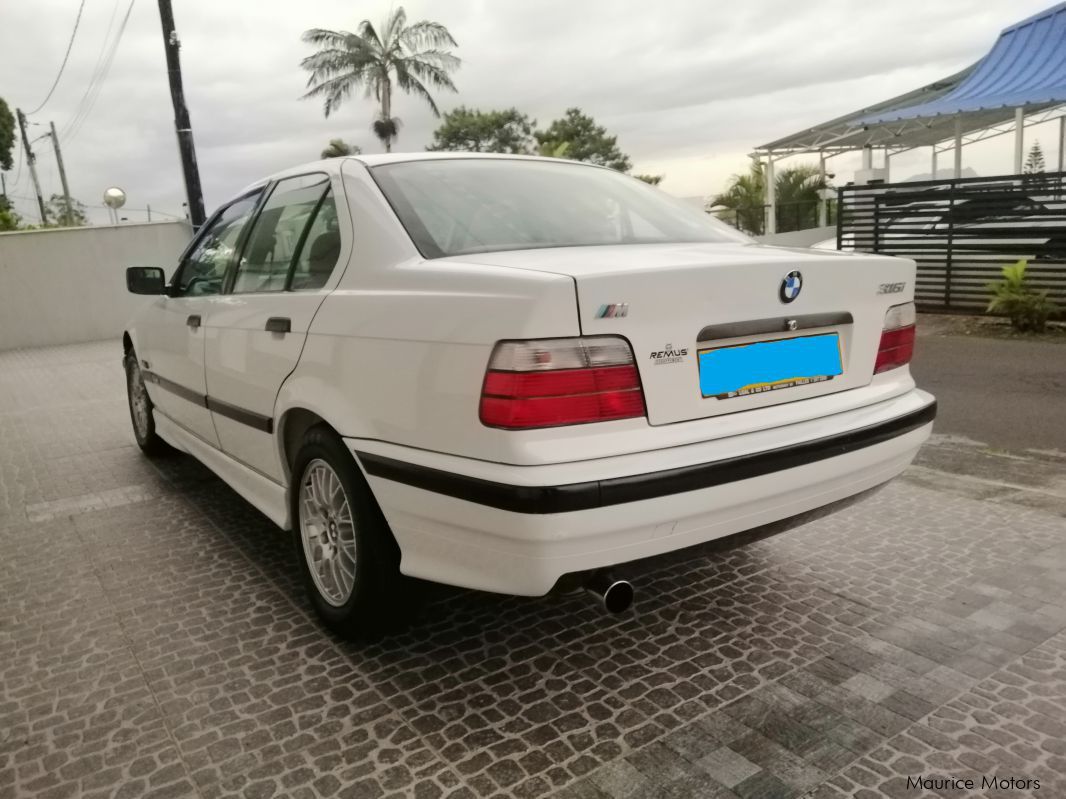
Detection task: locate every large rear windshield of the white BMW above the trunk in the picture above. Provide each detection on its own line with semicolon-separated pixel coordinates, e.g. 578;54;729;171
372;159;749;258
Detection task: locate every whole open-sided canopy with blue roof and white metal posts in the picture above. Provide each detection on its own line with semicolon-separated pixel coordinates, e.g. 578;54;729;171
753;2;1066;233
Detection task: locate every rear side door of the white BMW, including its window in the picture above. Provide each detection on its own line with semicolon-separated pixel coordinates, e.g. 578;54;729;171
205;173;351;482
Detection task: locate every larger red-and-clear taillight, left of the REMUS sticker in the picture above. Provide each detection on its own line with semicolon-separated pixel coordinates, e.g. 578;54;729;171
481;336;645;430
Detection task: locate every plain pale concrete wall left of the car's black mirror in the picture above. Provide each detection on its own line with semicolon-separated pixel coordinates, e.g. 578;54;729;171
0;222;192;350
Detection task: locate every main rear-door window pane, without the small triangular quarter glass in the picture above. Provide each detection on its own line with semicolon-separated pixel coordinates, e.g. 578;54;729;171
232;174;329;294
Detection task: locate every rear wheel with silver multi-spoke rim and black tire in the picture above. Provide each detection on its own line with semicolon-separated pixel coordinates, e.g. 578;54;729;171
289;426;417;640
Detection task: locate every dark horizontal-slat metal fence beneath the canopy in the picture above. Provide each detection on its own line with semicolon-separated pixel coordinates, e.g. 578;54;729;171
837;173;1066;313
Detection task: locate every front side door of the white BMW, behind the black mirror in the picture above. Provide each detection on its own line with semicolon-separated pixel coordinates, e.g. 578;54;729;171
138;191;261;446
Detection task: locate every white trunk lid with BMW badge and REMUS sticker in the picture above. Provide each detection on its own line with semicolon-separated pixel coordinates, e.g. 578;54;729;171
454;244;915;425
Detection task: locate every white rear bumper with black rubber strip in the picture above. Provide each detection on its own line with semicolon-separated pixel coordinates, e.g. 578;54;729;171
345;389;936;596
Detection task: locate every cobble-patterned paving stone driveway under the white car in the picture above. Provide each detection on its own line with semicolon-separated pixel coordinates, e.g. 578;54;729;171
0;343;1066;798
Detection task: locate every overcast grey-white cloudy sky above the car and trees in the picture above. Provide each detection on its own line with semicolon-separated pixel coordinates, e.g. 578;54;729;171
0;0;1057;221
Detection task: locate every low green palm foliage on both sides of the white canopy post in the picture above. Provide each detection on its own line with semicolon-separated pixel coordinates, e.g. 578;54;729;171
708;161;826;235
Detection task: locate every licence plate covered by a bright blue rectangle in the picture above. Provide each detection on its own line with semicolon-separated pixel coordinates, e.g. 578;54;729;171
698;333;843;400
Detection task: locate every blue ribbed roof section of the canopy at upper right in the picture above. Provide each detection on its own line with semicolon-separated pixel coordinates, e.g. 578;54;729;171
855;2;1066;125
